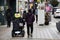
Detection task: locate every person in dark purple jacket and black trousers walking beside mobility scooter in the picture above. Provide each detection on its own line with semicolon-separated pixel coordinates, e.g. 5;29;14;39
26;9;35;37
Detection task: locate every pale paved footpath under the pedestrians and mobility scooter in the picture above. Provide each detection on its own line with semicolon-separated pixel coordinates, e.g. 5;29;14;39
0;14;60;40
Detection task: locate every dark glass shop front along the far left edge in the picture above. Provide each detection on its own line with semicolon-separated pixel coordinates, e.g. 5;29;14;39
0;0;5;25
